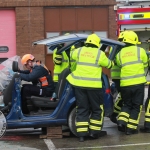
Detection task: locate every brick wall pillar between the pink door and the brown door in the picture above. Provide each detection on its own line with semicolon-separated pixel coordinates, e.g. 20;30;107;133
16;7;45;62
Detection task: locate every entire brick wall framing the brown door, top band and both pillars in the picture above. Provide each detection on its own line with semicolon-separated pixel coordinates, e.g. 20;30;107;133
0;0;116;62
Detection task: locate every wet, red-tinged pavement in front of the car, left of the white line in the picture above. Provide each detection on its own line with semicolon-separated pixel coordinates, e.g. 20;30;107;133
0;129;48;150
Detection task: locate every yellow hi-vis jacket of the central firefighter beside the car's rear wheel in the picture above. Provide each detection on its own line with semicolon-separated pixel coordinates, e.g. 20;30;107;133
67;47;112;88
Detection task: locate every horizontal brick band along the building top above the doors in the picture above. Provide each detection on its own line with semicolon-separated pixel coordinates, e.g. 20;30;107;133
0;0;116;7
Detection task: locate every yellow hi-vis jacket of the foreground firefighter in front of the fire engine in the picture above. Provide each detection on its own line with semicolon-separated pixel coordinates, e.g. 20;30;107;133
116;46;148;87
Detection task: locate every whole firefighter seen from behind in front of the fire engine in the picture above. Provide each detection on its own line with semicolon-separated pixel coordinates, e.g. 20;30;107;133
116;31;148;135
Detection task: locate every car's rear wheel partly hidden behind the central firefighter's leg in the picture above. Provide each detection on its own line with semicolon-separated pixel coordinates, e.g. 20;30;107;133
68;108;77;136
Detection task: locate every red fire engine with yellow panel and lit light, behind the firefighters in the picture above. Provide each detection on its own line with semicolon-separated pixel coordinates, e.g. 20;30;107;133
114;0;150;51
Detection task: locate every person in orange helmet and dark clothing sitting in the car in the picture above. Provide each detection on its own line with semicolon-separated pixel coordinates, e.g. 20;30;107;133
18;54;54;114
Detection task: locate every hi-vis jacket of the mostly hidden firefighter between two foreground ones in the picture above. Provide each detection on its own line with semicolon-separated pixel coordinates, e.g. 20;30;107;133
109;47;121;79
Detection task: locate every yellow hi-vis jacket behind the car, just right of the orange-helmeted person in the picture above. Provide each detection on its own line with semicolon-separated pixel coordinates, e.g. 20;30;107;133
53;49;69;82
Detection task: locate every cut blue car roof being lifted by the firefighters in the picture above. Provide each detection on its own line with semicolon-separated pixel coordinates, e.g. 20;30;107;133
32;34;125;60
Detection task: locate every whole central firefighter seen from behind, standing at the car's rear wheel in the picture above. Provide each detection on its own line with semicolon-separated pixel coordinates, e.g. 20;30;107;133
67;34;112;142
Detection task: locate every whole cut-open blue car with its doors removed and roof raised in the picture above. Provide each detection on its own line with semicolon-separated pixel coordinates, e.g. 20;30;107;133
0;34;124;135
